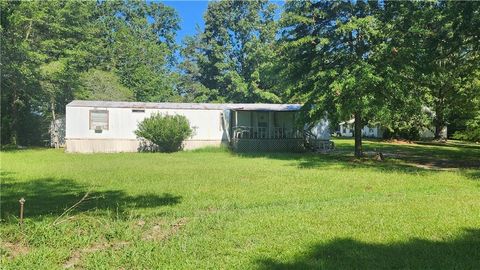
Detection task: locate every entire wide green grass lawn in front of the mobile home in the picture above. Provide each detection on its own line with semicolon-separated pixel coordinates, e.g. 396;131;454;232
0;140;480;269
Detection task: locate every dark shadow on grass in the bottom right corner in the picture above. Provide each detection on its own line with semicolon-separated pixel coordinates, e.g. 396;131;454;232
257;229;480;269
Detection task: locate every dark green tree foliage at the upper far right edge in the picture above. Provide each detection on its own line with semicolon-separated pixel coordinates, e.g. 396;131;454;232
382;1;480;139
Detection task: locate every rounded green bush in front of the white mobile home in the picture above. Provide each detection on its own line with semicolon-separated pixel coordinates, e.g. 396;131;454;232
135;113;193;153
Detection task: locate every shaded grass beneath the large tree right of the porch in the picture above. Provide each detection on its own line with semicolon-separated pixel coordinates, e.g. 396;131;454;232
236;140;480;179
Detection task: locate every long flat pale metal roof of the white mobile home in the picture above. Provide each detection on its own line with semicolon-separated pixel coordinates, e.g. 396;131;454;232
67;100;302;111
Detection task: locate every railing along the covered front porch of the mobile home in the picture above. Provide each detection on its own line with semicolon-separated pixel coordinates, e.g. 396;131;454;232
233;126;304;139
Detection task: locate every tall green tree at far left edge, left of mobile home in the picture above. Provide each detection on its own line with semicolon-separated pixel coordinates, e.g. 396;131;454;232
1;1;95;144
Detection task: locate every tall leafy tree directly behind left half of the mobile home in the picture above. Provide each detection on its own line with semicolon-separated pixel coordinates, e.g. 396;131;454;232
98;1;179;102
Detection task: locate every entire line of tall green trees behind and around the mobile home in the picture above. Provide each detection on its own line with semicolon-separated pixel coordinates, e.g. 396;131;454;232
0;0;480;150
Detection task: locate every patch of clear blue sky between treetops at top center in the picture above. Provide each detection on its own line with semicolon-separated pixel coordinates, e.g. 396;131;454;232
162;0;283;43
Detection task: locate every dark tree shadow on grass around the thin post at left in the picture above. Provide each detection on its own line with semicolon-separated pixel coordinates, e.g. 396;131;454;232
0;176;181;219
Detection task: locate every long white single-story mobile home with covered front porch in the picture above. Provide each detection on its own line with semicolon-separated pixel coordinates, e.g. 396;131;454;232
65;100;330;153
